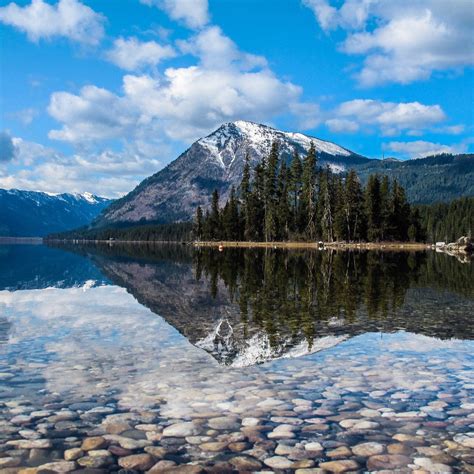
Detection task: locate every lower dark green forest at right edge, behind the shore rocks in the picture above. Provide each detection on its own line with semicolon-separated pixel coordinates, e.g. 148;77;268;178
415;197;474;242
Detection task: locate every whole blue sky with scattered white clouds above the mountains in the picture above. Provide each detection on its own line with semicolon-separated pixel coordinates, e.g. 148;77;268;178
0;0;474;197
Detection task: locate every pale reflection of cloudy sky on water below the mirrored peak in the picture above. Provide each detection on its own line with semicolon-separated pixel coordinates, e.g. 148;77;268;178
0;285;474;416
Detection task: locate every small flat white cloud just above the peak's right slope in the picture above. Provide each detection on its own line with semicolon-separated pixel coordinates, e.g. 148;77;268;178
326;99;446;135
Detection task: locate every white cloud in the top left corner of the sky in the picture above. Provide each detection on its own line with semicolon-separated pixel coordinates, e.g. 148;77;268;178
0;0;104;45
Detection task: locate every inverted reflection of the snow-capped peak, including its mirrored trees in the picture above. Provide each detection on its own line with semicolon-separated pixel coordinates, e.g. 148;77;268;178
52;246;474;366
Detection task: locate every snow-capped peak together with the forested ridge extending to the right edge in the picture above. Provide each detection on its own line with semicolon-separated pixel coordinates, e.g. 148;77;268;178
94;121;474;227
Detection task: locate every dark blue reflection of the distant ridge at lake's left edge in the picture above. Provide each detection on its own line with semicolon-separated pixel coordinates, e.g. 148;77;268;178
0;245;105;291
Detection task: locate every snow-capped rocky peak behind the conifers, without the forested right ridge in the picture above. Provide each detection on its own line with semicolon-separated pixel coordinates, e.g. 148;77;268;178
95;120;370;226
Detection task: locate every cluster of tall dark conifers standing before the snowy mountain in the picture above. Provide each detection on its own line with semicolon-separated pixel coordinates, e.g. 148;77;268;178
194;142;425;242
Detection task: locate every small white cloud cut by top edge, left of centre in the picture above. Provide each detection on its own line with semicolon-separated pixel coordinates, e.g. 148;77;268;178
140;0;209;28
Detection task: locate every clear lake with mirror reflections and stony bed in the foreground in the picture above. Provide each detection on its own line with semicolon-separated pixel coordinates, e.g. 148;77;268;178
0;243;474;474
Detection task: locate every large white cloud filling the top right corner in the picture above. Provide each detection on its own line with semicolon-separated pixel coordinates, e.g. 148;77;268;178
303;0;474;86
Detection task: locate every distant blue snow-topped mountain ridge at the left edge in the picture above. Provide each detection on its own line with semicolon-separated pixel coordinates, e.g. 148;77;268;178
0;189;112;237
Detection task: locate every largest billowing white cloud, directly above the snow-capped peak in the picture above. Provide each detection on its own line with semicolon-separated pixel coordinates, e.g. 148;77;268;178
48;27;317;143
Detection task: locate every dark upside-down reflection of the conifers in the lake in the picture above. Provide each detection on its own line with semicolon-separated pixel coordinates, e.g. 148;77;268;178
195;248;474;345
